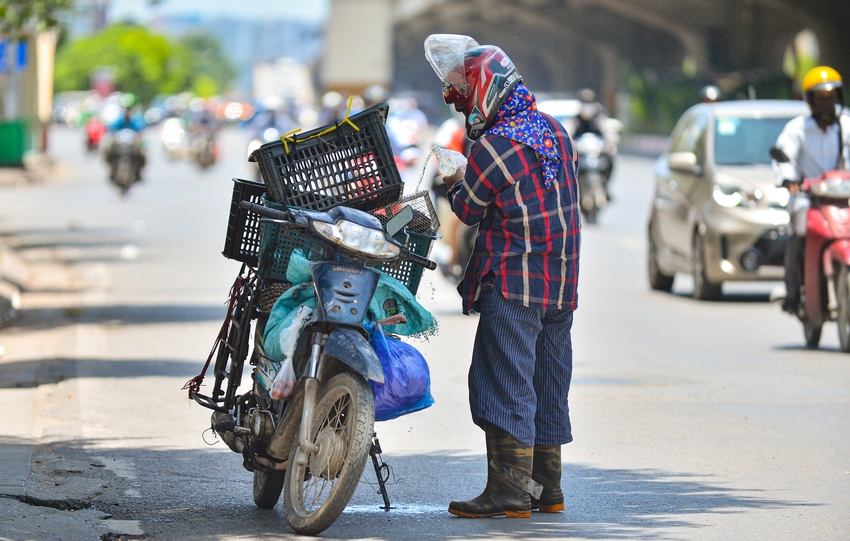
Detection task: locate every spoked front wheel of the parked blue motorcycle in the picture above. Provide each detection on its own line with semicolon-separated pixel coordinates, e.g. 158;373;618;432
283;372;375;535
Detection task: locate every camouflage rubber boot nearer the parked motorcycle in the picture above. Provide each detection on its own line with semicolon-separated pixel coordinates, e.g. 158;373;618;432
449;427;534;518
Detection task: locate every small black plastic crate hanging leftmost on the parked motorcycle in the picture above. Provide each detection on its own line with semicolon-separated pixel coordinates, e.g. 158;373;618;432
221;178;266;267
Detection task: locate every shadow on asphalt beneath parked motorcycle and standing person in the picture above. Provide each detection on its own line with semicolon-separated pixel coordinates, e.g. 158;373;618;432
18;440;820;541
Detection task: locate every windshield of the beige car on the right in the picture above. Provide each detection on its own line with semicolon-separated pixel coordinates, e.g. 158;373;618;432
714;116;791;165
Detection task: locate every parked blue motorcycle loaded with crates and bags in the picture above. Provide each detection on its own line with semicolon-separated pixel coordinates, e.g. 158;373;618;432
187;201;436;535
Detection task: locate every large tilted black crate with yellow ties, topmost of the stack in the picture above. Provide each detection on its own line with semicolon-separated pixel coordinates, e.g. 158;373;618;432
249;103;403;210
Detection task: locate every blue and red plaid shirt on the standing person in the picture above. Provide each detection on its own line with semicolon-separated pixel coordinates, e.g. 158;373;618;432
448;115;581;314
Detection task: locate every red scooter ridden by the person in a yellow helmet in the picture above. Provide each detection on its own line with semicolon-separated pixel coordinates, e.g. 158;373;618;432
770;147;850;353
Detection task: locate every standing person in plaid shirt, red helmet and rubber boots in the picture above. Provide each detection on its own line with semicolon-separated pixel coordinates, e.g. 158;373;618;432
425;34;581;518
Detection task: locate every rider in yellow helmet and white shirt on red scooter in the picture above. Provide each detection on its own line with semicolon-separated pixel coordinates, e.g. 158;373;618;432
774;66;850;314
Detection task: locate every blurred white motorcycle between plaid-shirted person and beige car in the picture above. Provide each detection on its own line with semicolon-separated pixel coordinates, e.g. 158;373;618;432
575;132;611;224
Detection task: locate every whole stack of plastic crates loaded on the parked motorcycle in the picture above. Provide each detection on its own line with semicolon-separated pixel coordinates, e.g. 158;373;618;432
222;104;439;294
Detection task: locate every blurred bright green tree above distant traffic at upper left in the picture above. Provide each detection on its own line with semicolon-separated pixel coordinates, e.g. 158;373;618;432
55;24;194;102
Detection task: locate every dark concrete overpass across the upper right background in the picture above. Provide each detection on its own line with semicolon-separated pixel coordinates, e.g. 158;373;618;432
328;0;850;114
